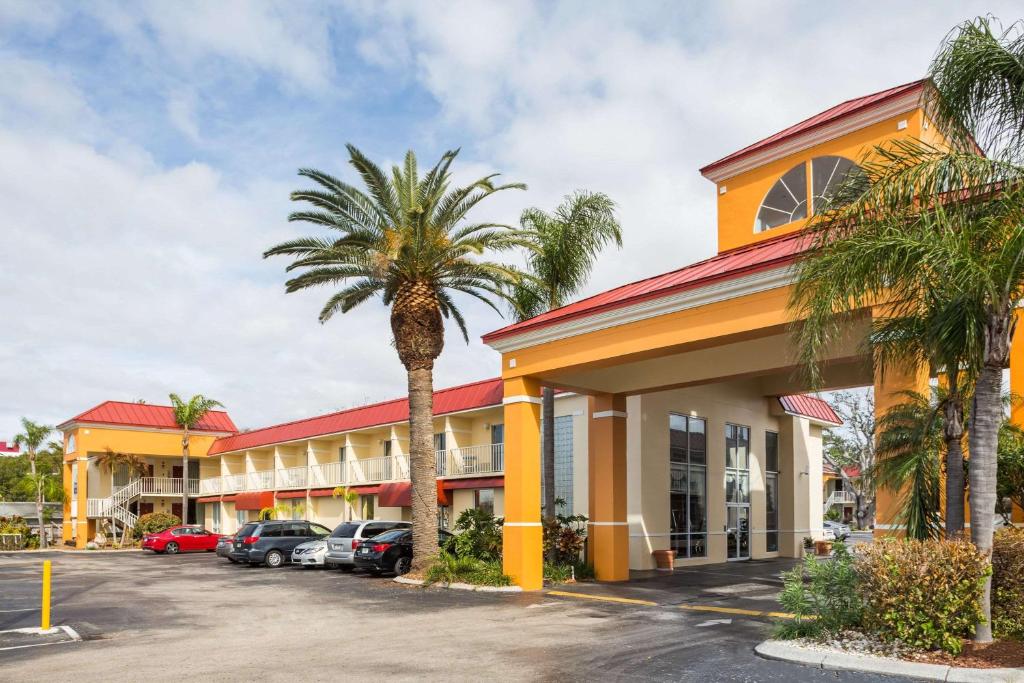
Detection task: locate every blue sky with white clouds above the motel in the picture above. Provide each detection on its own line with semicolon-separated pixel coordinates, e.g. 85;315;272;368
0;0;1022;439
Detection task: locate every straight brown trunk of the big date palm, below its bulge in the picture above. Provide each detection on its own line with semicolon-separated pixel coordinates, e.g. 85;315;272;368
408;367;437;573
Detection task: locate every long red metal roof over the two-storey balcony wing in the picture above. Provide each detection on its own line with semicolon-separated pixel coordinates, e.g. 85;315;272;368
210;378;503;456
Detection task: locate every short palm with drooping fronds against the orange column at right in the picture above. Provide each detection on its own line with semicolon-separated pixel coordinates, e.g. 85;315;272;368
872;391;942;540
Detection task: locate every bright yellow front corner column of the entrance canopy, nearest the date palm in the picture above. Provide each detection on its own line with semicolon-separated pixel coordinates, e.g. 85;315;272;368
503;377;544;591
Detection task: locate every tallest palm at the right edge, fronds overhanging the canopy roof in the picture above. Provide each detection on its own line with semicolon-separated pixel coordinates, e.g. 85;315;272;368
793;18;1024;642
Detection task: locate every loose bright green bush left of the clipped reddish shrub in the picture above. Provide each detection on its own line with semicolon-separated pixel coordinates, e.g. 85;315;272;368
775;541;863;638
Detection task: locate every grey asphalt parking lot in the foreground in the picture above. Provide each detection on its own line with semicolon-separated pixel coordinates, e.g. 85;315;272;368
0;552;892;682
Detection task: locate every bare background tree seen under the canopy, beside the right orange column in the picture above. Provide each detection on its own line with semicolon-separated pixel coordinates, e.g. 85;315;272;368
822;391;874;528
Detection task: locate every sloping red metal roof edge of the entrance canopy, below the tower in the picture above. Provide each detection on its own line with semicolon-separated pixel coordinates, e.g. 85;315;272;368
483;232;810;343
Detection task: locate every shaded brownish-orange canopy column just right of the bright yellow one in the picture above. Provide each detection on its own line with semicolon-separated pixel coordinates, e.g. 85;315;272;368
587;394;630;581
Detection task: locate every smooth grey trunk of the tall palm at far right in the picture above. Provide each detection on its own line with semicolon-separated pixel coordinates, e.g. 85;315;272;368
969;313;1013;643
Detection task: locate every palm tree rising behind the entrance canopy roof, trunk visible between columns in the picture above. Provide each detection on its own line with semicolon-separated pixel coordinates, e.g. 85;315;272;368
511;190;623;518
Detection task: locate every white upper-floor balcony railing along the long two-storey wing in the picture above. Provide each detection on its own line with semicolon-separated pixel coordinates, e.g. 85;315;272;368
200;443;505;494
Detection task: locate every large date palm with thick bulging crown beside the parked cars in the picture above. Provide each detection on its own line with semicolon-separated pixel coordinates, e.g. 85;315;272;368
263;144;525;570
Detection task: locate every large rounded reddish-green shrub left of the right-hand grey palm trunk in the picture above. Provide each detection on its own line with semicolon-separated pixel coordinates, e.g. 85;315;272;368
857;539;989;654
